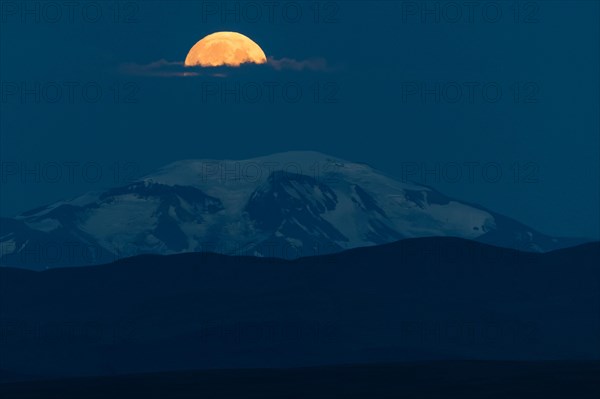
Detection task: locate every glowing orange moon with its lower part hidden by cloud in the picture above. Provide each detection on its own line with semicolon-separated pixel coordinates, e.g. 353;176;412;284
185;32;267;67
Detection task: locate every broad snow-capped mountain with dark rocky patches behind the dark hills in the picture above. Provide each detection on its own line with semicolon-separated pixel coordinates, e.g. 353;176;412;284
0;151;574;268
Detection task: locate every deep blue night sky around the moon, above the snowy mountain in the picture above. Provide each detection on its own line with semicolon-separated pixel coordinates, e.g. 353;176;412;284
0;1;600;238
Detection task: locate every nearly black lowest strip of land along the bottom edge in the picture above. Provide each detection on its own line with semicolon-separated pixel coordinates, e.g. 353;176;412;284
0;362;600;399
